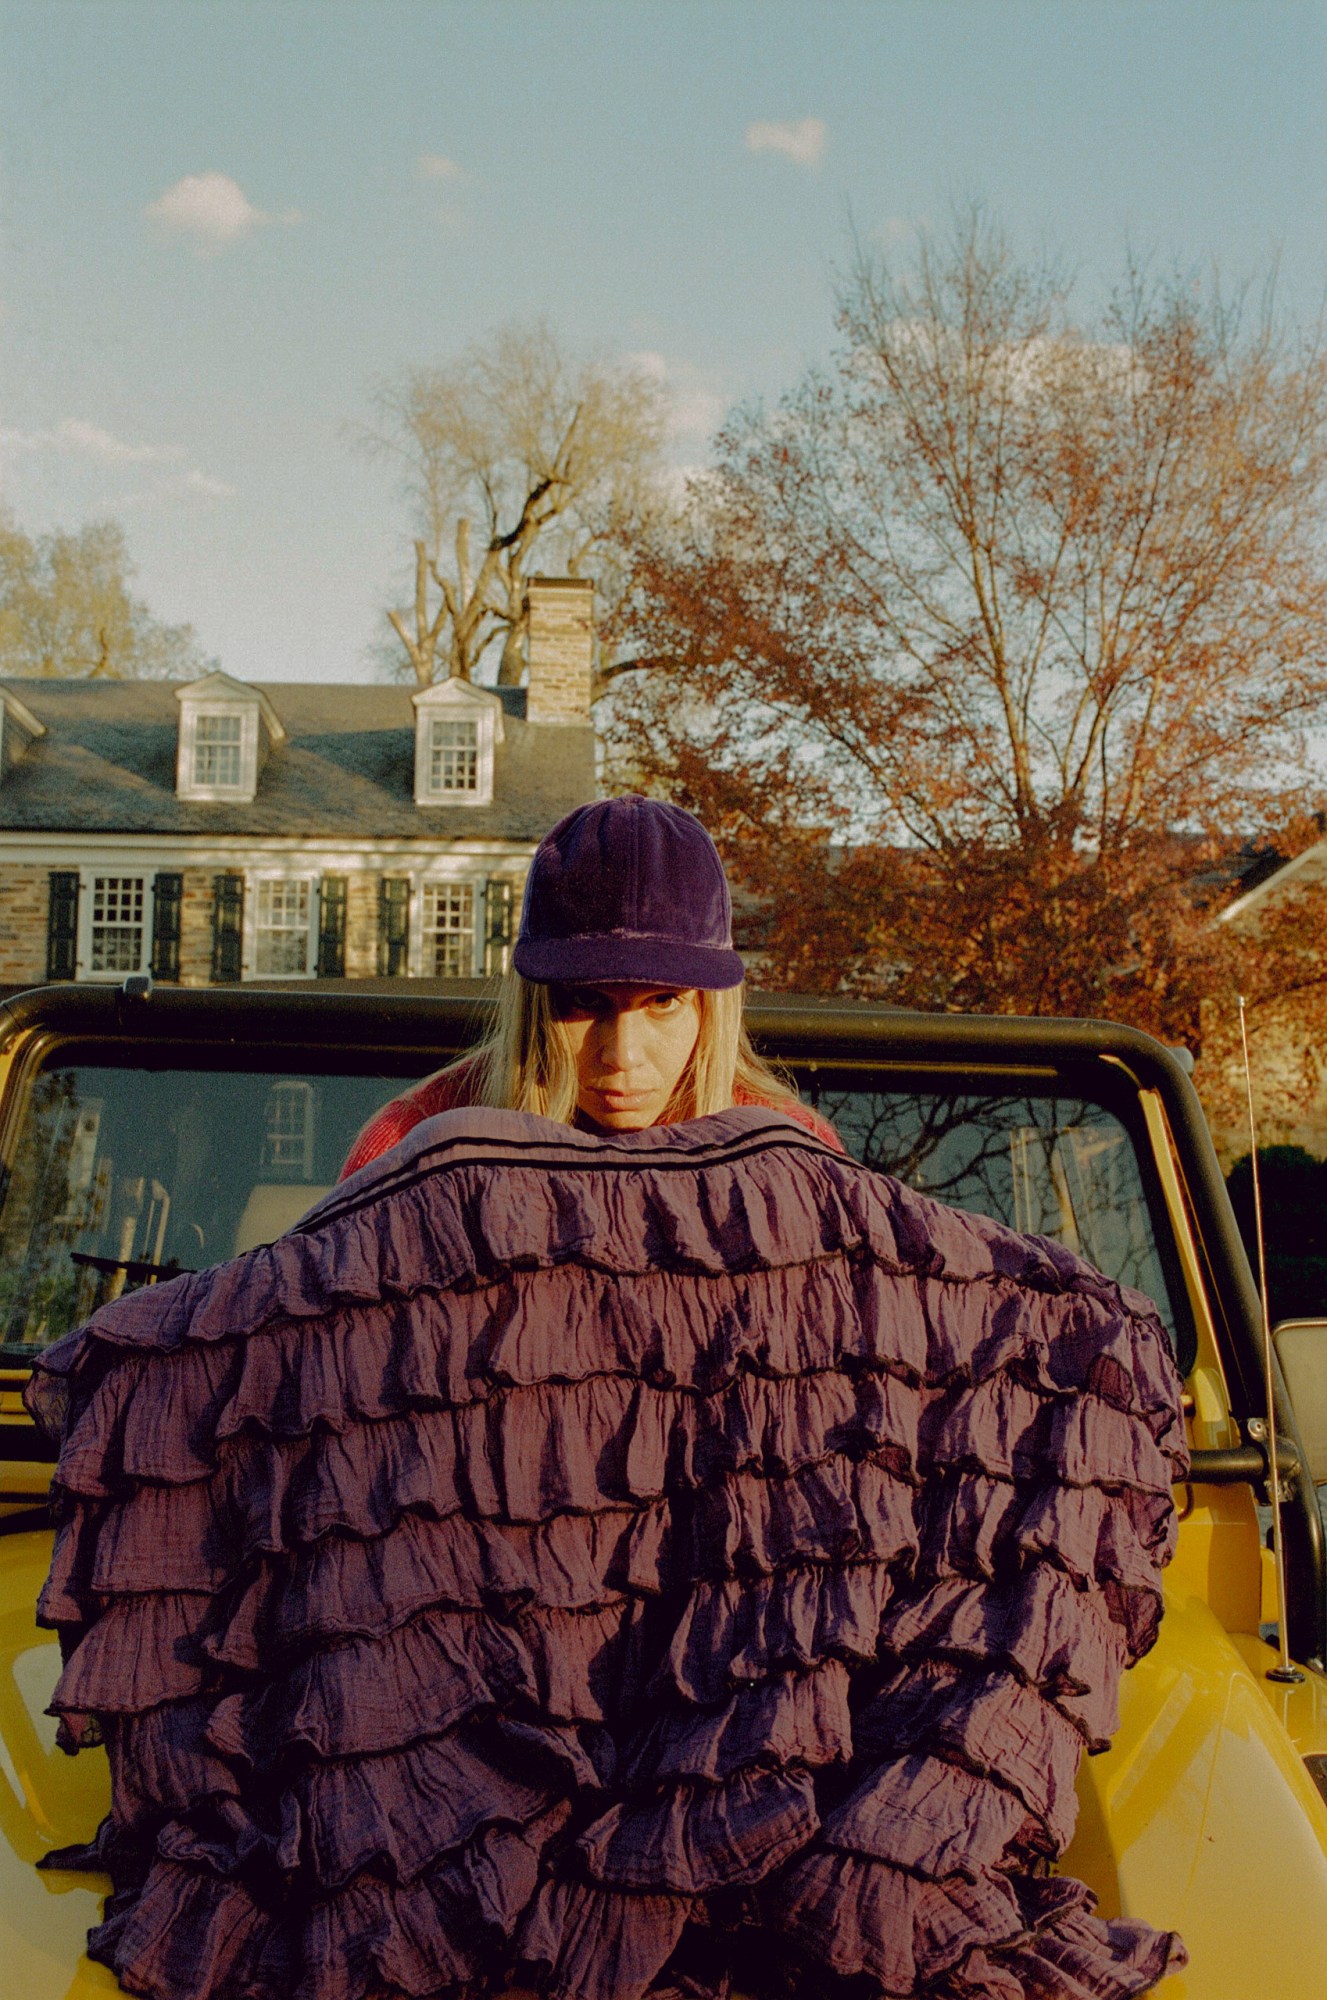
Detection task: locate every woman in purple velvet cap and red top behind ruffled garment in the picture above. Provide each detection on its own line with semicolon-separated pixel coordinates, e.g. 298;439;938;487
342;798;841;1178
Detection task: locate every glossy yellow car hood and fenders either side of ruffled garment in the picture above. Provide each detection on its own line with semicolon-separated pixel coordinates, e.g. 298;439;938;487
0;1532;1327;2000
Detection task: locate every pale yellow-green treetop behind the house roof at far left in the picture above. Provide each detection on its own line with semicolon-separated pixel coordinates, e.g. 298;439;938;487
0;512;216;680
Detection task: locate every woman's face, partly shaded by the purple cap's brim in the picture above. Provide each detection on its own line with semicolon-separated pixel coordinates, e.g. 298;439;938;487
554;984;699;1132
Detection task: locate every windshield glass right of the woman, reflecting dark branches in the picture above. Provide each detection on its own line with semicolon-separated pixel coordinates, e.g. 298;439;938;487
817;1090;1175;1340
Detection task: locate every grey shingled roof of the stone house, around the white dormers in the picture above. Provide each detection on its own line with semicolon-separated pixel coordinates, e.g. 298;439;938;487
0;680;596;840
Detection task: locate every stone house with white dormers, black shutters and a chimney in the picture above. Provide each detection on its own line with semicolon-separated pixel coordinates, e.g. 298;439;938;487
0;578;596;986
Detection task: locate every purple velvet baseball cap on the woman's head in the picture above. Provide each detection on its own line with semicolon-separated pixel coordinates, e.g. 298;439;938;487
512;796;743;990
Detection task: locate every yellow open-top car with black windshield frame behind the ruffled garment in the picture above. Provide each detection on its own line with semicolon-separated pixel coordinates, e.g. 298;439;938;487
0;980;1327;2000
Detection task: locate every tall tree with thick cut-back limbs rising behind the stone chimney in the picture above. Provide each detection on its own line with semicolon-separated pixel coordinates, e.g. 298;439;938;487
364;320;665;686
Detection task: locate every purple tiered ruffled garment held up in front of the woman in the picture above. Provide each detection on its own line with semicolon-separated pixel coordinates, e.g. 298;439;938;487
28;1108;1185;2000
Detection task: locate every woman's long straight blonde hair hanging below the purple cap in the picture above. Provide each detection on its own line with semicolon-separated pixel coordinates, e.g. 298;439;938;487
439;972;797;1124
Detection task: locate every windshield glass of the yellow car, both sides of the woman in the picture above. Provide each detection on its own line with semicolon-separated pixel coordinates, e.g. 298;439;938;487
0;1062;1175;1358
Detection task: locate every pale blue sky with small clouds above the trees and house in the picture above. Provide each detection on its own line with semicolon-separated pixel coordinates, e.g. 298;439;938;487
0;0;1327;680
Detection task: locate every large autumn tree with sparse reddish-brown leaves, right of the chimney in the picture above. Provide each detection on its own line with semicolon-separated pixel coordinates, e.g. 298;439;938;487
608;212;1327;1038
